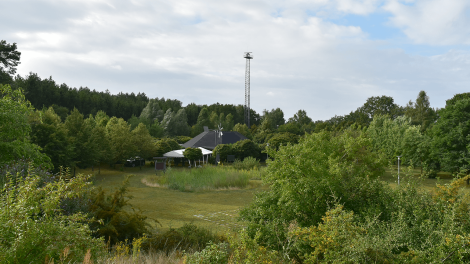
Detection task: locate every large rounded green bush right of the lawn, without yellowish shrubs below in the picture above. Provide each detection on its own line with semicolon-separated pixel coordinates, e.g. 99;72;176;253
242;129;390;252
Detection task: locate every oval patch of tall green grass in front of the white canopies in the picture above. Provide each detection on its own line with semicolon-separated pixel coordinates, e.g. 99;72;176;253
146;166;259;192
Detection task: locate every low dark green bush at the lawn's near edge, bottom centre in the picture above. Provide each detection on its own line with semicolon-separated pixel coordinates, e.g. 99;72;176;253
142;223;225;254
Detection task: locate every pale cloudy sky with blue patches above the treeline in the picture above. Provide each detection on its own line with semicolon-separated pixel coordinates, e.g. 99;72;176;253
0;0;470;120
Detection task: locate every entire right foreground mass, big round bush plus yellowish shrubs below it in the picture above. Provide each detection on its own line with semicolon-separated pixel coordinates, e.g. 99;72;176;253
241;127;470;263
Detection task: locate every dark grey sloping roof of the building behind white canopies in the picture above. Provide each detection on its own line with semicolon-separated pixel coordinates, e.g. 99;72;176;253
182;131;248;149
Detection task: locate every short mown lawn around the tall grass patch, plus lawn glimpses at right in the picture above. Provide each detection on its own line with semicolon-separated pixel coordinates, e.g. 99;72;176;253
78;165;464;232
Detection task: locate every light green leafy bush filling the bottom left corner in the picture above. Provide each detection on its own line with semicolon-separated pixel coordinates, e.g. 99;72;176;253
0;165;105;263
